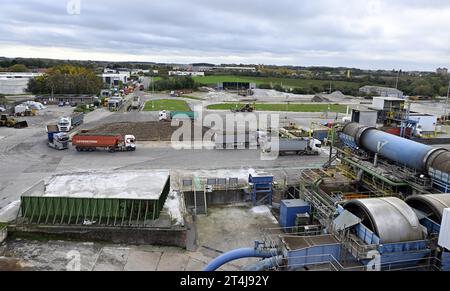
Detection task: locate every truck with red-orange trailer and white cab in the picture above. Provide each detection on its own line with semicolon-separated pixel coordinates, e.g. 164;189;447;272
72;133;136;153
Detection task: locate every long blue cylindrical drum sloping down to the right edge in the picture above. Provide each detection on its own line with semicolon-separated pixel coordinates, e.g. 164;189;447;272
341;123;450;175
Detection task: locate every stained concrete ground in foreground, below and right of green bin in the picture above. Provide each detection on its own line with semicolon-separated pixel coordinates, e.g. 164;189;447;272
0;206;277;271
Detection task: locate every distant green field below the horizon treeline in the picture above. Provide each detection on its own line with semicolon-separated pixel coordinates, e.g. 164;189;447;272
194;76;361;90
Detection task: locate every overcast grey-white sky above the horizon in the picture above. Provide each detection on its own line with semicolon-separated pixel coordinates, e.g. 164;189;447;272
0;0;450;70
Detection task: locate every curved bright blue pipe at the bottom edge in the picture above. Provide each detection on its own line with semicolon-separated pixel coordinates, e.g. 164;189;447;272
203;248;278;272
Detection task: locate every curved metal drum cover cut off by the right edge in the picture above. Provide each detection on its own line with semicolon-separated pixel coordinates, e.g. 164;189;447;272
406;194;450;224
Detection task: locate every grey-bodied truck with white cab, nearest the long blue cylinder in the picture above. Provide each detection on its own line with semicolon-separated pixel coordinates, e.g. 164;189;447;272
263;138;322;156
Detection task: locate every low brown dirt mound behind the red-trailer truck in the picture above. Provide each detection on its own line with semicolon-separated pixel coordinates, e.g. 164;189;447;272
87;122;213;141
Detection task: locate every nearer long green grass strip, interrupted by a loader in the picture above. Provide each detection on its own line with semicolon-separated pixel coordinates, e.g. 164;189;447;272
208;103;347;113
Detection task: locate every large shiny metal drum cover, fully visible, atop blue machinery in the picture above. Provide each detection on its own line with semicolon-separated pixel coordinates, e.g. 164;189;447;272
344;197;424;244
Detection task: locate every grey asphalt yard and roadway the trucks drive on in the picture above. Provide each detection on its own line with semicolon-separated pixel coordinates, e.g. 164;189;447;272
0;104;326;221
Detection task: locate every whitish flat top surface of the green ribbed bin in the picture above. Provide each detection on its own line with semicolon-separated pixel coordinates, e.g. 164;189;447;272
23;170;170;200
